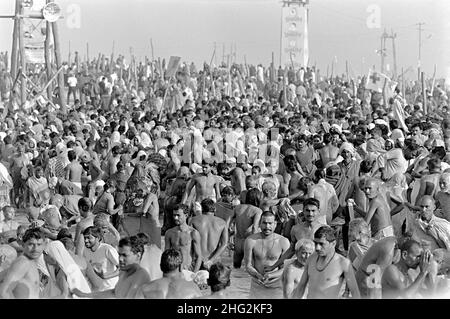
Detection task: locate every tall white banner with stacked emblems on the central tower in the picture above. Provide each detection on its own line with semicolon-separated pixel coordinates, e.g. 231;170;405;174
281;3;309;68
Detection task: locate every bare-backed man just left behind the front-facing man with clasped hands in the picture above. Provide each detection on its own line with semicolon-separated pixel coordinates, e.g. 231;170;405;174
232;188;262;268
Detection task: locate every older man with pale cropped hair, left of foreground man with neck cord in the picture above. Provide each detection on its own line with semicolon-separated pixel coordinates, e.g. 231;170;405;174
282;239;314;299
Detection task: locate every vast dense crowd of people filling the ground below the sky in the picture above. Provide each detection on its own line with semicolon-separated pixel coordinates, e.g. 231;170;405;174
0;52;450;299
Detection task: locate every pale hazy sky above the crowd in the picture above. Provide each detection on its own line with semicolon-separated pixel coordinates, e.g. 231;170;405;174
0;0;450;77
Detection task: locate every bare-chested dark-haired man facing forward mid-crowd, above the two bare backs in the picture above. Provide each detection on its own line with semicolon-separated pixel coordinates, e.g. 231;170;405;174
181;161;220;214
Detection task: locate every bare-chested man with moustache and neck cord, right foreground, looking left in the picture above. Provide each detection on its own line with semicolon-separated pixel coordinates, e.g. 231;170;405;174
293;226;360;299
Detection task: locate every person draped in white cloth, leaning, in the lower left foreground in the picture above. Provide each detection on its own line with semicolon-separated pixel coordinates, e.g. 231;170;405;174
43;240;91;299
